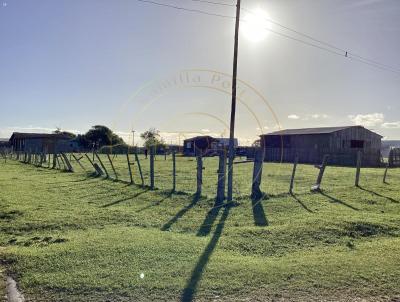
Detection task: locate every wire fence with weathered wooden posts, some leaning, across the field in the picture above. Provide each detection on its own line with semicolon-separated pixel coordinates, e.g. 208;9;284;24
2;153;400;198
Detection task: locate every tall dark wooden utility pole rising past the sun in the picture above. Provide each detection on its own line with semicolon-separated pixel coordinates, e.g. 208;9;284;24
227;0;240;202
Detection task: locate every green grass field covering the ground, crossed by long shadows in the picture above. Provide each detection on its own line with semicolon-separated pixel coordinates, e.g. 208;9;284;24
0;155;400;301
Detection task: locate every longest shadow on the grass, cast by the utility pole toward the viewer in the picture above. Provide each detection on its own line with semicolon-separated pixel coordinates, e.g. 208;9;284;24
181;206;231;302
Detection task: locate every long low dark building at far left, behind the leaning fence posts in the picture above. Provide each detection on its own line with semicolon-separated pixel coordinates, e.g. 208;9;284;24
9;132;78;153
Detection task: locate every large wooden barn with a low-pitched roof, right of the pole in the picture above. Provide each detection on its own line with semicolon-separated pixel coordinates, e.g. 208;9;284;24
260;126;382;167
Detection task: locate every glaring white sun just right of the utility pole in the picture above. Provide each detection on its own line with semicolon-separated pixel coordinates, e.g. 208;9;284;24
241;8;271;42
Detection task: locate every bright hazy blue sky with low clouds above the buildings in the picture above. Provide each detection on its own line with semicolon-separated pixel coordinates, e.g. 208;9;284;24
0;0;400;143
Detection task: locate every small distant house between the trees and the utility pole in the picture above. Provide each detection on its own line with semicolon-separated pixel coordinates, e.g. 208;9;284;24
183;136;238;156
